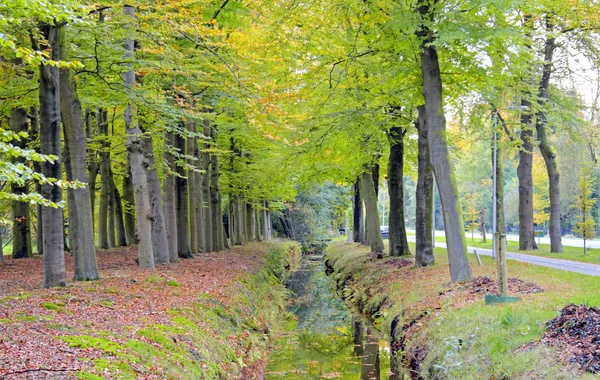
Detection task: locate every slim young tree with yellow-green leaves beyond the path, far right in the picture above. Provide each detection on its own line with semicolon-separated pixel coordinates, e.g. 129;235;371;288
573;164;597;255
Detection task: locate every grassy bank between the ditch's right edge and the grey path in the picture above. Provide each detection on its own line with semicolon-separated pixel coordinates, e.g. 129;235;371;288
326;242;600;379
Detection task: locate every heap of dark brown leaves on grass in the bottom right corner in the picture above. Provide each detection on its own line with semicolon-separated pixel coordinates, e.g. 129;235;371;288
542;304;600;374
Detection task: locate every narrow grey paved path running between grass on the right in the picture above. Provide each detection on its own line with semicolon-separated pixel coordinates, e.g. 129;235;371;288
408;236;600;276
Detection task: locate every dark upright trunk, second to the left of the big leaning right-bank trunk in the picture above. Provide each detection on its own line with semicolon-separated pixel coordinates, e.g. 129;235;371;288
388;126;410;256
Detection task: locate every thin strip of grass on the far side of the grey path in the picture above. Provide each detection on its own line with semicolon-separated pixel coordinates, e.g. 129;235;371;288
408;232;600;264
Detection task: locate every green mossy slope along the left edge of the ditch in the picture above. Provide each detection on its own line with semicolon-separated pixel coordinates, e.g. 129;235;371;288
57;241;300;379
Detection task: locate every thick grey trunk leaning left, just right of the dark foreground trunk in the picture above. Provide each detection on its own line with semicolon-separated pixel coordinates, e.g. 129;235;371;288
59;35;100;281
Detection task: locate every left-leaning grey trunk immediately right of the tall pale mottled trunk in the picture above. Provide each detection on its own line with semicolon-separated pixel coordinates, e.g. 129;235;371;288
143;135;170;264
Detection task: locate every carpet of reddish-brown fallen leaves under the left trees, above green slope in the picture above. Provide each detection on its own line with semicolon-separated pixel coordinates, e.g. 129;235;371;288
0;244;263;379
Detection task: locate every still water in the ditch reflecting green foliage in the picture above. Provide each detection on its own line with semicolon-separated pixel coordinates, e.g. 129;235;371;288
265;254;390;380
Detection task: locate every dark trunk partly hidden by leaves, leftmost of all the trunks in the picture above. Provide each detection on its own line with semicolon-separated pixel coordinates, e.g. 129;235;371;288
9;108;31;259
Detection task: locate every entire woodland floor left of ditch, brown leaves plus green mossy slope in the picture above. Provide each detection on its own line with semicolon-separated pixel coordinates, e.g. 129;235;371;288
0;243;298;379
